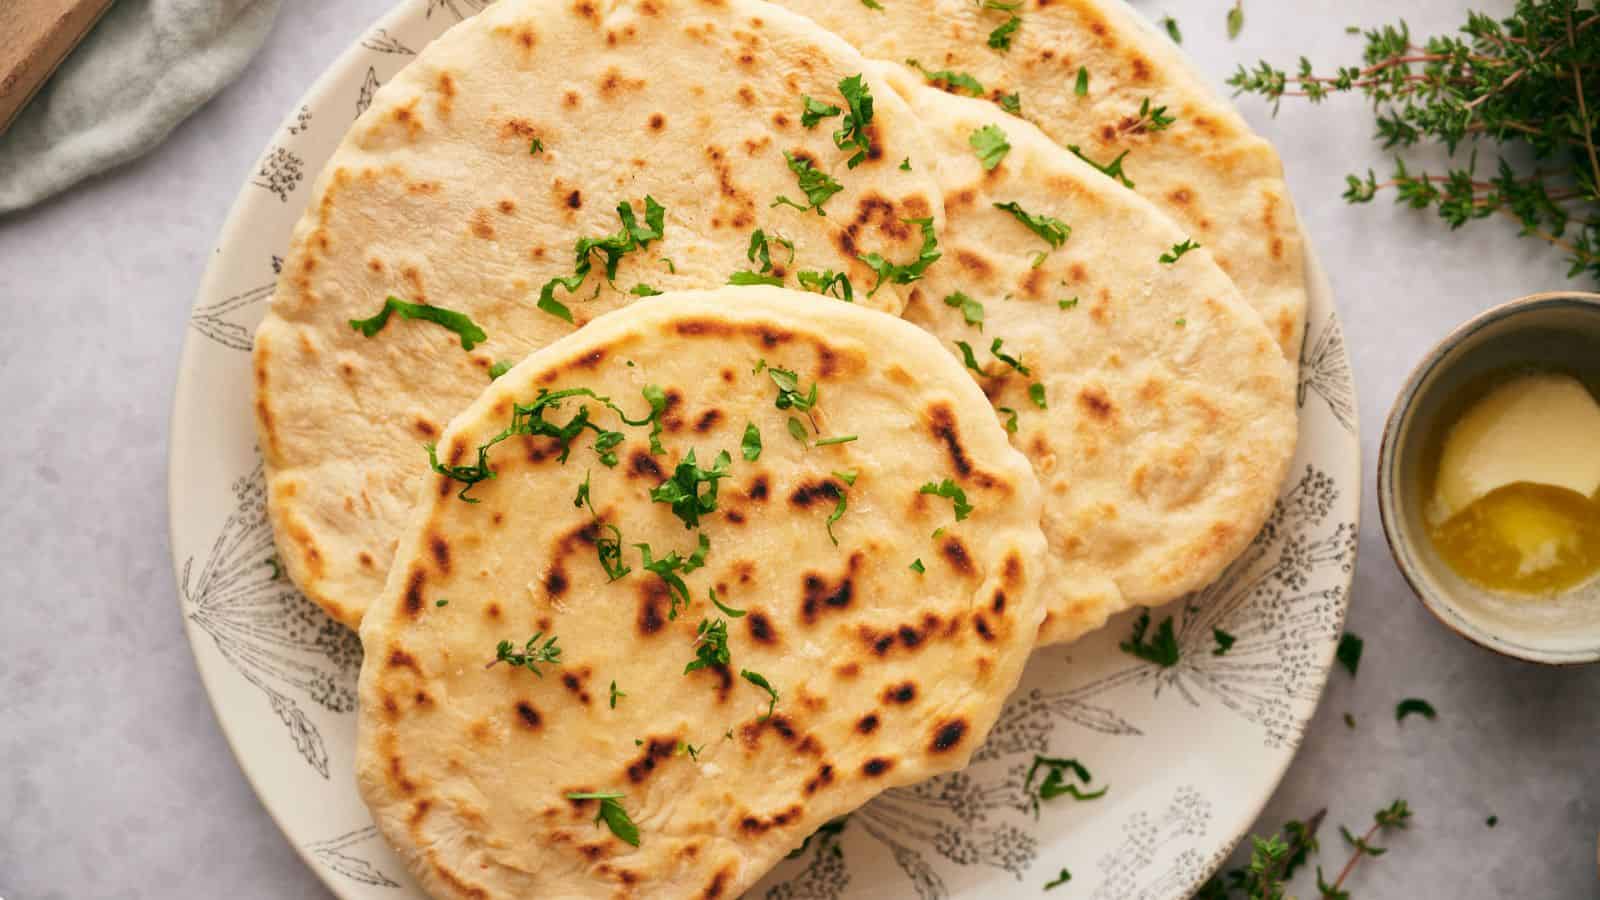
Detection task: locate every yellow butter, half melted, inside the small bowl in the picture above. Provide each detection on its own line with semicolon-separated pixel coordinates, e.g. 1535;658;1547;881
1427;372;1600;597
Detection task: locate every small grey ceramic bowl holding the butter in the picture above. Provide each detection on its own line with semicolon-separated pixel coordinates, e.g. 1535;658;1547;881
1378;291;1600;665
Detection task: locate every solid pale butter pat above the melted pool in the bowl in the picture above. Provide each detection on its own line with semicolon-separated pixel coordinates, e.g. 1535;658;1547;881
1429;375;1600;524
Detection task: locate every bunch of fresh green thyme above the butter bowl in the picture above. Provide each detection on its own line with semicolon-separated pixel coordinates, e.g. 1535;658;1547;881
1229;0;1600;280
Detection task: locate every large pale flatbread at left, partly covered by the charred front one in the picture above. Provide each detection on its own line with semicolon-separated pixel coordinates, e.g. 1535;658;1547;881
254;0;942;625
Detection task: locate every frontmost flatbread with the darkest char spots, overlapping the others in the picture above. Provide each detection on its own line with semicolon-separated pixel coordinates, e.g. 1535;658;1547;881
357;287;1043;900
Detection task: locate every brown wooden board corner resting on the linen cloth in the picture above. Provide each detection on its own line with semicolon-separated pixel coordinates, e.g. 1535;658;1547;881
0;0;112;135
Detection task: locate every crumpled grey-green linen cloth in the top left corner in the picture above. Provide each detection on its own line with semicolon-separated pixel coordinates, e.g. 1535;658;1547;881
0;0;280;215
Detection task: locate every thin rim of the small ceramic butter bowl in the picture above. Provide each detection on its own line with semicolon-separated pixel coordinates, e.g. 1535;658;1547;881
1374;290;1600;666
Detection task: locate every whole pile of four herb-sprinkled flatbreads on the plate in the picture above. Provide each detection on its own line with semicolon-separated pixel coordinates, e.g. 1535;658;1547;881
254;0;1306;898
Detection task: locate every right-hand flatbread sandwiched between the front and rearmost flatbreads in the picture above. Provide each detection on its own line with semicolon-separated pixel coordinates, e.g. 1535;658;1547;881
890;70;1296;642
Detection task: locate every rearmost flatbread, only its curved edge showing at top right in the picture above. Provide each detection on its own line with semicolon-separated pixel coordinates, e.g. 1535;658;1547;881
778;0;1307;360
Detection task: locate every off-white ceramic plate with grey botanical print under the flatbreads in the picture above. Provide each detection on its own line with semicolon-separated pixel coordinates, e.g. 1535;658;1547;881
170;0;1362;900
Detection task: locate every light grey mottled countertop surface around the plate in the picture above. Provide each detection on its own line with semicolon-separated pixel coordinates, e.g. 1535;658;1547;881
0;0;1600;900
